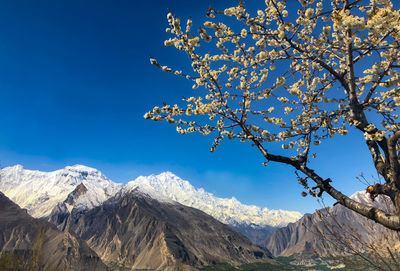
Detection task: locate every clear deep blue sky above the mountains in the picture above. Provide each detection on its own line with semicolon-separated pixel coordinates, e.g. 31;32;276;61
0;0;374;212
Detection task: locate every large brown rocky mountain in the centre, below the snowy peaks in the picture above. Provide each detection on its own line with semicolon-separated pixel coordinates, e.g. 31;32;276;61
48;187;269;270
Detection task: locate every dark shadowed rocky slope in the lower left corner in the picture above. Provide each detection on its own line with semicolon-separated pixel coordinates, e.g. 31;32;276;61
0;192;107;271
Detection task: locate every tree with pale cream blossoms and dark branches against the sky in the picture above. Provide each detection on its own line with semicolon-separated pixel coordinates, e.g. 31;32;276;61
144;0;400;231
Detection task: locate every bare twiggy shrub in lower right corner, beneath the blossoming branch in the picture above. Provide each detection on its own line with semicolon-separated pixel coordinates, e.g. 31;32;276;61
314;196;400;271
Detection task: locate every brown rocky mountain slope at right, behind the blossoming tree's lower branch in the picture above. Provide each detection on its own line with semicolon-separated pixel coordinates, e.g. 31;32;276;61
262;192;399;256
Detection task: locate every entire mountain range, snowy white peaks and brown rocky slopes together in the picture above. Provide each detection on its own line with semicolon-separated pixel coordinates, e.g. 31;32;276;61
0;165;399;270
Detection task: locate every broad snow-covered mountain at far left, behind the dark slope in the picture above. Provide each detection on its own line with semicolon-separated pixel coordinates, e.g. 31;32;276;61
0;165;122;217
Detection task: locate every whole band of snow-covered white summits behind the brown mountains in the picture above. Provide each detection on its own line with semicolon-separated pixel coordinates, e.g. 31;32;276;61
0;165;302;227
